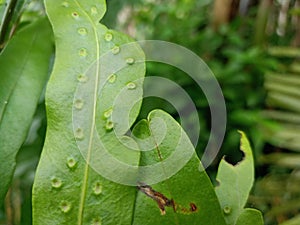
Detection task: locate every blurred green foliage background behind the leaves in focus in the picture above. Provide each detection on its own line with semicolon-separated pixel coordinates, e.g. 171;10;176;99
0;0;300;225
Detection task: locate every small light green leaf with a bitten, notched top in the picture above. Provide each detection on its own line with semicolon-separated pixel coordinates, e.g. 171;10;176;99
216;132;254;224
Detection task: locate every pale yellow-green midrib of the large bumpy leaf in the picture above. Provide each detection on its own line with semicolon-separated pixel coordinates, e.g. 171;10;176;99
75;0;100;225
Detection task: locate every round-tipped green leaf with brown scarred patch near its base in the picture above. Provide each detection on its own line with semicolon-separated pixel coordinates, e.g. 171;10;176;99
133;110;225;225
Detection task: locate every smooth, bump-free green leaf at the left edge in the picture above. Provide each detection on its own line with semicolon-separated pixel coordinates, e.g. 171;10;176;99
0;19;53;201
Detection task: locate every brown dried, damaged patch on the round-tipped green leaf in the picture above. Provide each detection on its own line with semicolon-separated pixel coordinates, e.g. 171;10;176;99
137;183;198;215
